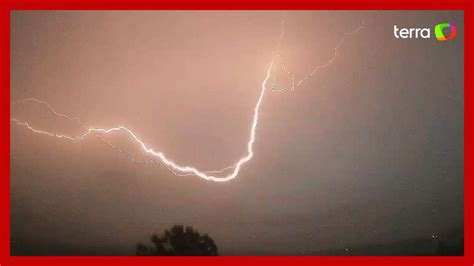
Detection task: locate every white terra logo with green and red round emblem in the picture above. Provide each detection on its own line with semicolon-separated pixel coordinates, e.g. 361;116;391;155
393;23;457;41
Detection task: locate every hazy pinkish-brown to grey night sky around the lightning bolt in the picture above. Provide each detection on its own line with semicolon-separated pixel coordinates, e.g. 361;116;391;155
10;11;464;255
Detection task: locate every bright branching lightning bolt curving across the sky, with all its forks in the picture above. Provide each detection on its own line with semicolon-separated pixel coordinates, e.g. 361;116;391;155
10;12;363;182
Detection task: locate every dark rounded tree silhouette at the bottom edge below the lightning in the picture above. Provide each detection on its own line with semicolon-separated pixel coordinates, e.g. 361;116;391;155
137;225;218;256
